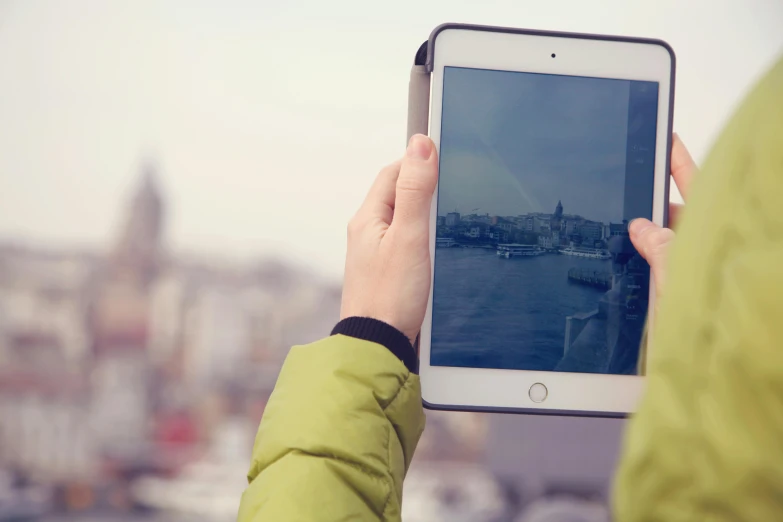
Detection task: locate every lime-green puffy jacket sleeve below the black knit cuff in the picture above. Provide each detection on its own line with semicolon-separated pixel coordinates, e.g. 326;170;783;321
238;335;424;522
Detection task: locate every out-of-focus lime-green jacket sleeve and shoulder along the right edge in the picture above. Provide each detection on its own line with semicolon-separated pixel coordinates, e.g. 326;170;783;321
614;62;783;522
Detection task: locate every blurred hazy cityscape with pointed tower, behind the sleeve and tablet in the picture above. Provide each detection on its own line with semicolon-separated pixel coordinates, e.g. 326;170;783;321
0;159;611;522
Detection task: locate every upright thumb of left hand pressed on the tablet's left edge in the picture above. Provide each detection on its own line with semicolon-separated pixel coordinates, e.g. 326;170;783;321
392;134;438;232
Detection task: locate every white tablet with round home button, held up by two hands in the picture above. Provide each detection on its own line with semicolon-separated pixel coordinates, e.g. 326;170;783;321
419;25;674;416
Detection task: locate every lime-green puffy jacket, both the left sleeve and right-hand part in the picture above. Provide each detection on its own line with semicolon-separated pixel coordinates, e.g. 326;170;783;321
239;58;783;522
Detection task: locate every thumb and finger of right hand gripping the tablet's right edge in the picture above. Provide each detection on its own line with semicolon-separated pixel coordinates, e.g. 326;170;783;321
628;134;697;301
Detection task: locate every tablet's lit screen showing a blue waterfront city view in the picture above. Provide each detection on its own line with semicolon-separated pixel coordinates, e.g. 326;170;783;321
430;67;658;374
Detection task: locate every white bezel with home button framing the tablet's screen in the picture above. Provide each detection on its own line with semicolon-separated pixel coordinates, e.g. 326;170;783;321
419;28;674;415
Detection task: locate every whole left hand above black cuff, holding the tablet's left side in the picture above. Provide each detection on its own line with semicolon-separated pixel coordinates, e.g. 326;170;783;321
340;135;438;342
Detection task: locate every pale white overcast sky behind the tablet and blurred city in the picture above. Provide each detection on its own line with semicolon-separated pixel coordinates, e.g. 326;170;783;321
0;0;783;277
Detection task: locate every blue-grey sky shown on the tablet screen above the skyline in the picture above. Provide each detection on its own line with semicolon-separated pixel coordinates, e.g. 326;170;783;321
438;68;630;223
